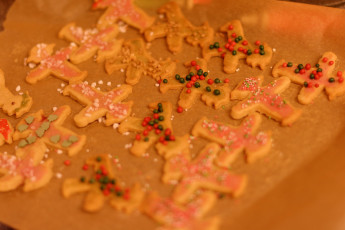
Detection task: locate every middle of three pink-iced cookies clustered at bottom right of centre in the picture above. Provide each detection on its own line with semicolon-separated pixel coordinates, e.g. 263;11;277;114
163;143;247;203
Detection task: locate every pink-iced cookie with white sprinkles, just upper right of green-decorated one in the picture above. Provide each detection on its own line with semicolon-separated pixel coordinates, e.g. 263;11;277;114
63;82;133;127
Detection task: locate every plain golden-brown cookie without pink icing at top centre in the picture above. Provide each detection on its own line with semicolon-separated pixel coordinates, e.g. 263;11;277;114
145;2;214;53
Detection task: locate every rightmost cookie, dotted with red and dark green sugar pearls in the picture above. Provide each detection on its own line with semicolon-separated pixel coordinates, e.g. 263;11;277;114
272;52;345;104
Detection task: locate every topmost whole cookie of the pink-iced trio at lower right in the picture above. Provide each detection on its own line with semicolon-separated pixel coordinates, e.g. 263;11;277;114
192;113;272;168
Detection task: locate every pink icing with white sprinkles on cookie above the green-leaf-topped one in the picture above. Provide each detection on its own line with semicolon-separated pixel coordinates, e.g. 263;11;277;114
71;83;130;118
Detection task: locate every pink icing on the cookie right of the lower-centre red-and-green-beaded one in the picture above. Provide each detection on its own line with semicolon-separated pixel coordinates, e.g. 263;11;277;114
202;116;269;161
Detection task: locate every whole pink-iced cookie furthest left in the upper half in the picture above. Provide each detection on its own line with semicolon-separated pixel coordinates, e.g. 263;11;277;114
26;43;87;84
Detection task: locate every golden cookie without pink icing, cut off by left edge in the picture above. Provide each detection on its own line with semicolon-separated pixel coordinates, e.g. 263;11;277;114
0;69;32;118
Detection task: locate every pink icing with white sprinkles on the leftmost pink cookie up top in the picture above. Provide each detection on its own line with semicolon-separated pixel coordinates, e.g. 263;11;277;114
27;44;80;78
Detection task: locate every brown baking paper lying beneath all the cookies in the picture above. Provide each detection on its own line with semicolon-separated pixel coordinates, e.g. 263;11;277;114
0;0;345;229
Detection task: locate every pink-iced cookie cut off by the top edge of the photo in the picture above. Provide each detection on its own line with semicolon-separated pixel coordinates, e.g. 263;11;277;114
92;0;154;33
